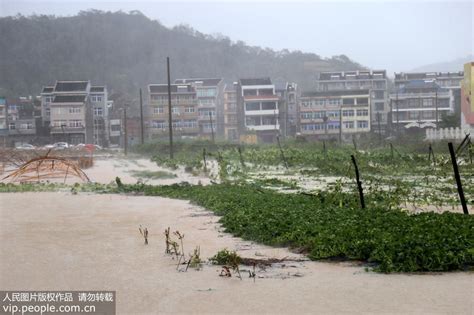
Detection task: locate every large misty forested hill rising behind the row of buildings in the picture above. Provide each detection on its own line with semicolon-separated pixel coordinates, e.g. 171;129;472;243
0;10;361;96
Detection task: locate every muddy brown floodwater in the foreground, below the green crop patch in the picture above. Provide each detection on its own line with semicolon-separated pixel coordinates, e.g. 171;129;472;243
0;192;474;314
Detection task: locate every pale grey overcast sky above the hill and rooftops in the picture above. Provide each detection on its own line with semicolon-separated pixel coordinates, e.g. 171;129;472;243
0;0;474;73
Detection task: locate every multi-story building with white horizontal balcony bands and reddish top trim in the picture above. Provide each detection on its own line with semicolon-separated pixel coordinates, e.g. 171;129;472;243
236;78;280;142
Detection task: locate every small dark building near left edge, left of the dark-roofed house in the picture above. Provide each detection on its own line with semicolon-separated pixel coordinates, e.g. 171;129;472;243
7;97;36;143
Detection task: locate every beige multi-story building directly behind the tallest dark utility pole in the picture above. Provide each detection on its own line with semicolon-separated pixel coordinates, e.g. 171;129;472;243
145;84;200;139
